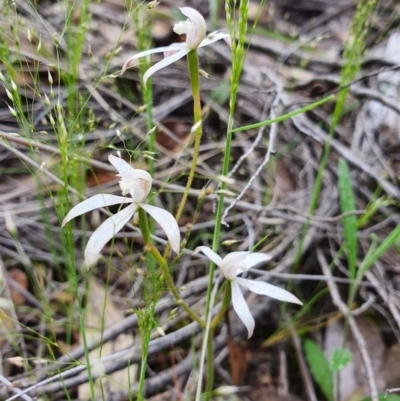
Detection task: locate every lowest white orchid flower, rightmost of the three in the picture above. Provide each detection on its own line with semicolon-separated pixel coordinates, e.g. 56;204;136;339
195;246;303;338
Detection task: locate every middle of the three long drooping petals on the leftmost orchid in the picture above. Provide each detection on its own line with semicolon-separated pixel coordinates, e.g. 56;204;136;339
85;203;137;268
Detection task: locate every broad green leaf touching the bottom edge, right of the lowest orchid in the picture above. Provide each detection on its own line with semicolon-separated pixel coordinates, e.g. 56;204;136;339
304;340;333;401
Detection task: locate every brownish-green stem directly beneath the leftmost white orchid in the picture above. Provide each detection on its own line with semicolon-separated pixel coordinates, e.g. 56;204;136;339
138;207;205;328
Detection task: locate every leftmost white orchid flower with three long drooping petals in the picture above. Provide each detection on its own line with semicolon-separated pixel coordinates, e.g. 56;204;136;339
62;155;180;268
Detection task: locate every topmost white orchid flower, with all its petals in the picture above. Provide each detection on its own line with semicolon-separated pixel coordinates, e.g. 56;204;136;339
121;7;229;86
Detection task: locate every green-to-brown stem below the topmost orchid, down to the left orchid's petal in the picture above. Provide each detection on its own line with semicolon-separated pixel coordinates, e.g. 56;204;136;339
175;50;203;221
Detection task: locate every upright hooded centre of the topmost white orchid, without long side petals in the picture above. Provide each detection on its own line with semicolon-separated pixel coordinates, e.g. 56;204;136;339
174;7;207;50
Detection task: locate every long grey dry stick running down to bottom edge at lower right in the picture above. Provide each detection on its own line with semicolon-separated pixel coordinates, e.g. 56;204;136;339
317;248;379;401
